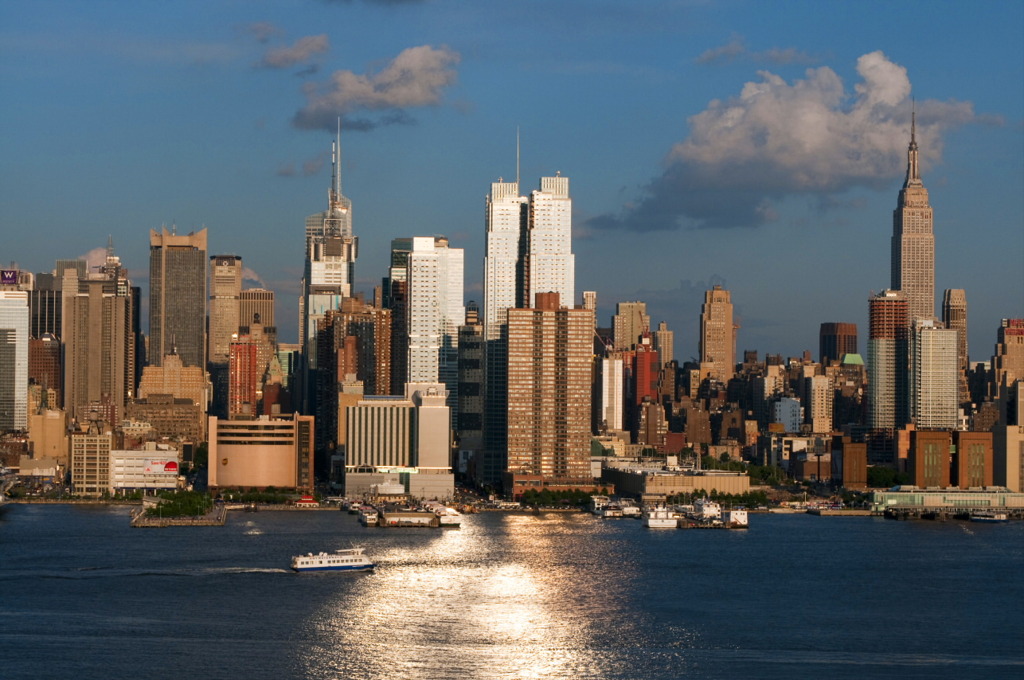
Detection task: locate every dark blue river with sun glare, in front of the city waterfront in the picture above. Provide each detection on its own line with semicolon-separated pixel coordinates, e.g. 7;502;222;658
0;505;1024;680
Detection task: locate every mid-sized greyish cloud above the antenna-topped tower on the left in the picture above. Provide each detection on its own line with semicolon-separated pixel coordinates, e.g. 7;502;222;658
294;45;461;130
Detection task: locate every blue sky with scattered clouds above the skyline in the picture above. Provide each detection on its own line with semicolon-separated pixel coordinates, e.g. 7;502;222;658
0;0;1024;360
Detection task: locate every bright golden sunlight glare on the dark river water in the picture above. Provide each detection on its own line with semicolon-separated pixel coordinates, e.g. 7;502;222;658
303;515;629;679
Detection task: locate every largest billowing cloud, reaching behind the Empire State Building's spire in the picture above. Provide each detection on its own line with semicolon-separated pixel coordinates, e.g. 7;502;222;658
592;51;978;230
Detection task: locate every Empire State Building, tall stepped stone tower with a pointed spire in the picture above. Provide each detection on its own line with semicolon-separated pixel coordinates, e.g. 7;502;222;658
892;112;935;323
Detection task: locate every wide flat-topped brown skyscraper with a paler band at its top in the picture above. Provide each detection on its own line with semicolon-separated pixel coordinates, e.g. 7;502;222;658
150;228;207;368
